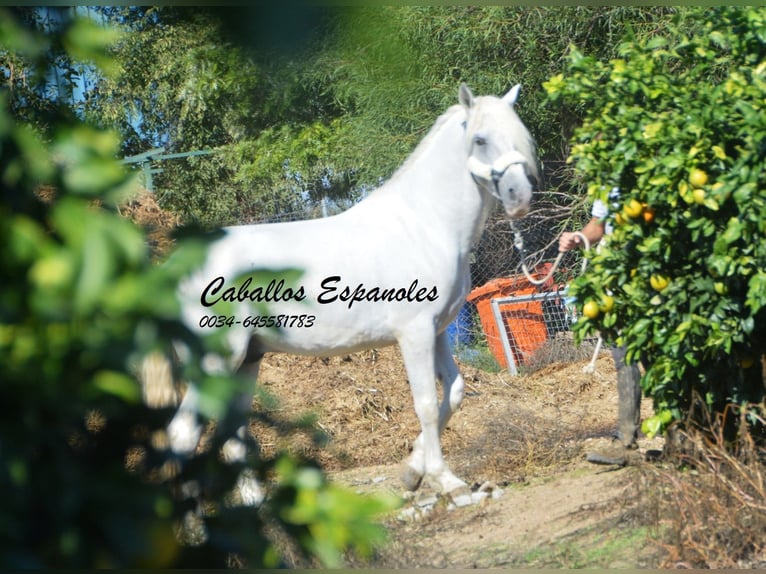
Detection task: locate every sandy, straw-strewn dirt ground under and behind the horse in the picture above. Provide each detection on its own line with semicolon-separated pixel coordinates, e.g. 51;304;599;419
252;348;662;568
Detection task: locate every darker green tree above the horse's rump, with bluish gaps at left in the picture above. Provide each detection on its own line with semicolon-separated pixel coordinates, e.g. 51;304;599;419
89;6;344;226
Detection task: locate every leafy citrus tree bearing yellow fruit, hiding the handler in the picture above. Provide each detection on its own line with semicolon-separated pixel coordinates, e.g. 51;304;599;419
545;7;766;440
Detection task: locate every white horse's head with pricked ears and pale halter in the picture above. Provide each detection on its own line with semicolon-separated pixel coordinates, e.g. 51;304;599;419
458;84;539;218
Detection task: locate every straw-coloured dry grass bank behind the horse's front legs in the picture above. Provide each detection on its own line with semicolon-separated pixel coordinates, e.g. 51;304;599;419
251;348;614;482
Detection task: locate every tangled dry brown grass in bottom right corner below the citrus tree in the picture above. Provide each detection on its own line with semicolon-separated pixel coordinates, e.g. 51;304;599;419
643;410;766;569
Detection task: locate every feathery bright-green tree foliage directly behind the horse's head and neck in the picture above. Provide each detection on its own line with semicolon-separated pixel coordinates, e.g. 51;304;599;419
311;6;667;185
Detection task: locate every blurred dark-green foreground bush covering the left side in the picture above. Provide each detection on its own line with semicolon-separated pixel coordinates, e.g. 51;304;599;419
0;10;391;568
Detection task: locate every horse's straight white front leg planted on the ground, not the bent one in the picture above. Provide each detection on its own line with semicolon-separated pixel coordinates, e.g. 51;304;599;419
399;325;467;493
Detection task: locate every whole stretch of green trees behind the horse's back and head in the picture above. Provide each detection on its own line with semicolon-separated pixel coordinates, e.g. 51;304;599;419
82;6;684;232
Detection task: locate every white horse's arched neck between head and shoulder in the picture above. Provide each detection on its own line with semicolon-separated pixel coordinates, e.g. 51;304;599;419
390;113;492;254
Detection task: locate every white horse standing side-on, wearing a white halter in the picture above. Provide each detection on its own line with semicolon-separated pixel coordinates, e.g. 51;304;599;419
147;85;538;503
